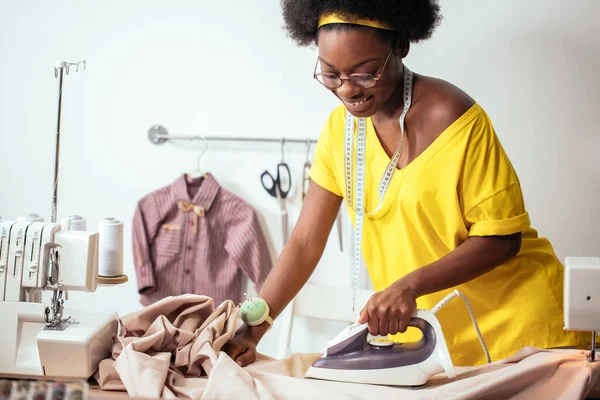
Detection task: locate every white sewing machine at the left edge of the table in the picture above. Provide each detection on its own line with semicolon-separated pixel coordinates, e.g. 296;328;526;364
0;217;118;381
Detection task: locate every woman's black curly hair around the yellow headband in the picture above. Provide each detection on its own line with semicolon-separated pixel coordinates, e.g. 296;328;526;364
281;0;442;46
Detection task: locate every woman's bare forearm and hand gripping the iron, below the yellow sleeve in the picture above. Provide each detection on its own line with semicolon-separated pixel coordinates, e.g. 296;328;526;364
359;233;521;336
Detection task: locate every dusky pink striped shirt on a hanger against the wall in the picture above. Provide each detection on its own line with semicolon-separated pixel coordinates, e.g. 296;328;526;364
133;174;272;306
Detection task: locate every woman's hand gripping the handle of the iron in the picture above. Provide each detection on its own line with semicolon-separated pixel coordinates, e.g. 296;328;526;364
358;281;417;336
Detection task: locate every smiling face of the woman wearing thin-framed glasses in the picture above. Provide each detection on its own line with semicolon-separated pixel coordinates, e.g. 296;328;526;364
317;29;402;117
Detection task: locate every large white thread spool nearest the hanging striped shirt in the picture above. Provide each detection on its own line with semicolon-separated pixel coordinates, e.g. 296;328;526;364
98;218;123;276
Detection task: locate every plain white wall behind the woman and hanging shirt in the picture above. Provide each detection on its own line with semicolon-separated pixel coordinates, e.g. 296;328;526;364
0;0;600;354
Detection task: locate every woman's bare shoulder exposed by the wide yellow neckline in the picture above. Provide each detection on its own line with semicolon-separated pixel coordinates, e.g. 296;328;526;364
413;74;475;136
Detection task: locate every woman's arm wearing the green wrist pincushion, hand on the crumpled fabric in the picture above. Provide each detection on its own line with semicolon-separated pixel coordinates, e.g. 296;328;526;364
224;181;342;366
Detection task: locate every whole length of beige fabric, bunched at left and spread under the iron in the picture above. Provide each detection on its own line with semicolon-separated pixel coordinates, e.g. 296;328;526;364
95;295;600;400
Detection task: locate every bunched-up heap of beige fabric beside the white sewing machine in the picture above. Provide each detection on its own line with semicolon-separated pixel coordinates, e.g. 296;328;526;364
95;294;241;398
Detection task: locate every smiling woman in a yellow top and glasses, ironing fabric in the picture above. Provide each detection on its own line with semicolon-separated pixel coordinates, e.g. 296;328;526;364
225;0;582;366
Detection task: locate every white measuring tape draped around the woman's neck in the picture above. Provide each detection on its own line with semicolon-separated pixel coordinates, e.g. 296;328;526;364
344;65;413;312
